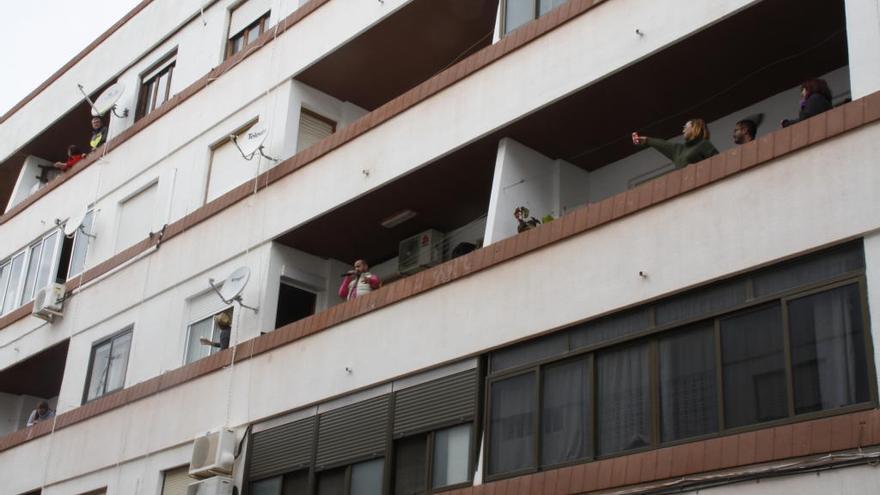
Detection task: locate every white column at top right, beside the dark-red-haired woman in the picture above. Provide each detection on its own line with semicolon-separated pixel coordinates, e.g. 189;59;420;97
846;0;880;99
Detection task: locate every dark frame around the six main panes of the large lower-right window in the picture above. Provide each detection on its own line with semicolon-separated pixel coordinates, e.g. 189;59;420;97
482;276;880;481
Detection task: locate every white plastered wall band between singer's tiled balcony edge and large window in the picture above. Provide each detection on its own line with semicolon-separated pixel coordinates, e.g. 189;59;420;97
0;119;880;493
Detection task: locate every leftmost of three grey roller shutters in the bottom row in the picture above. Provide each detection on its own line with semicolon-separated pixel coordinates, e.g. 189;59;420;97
248;417;315;480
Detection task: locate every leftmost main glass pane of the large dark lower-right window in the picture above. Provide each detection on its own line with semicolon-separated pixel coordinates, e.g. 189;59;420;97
489;373;537;474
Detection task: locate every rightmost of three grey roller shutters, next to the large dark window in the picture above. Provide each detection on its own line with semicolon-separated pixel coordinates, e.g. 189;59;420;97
394;369;477;437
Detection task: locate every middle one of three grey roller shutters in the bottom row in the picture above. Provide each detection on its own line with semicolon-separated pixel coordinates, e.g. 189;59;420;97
316;395;391;469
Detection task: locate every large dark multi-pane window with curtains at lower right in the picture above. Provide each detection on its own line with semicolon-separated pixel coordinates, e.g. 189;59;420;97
488;243;873;480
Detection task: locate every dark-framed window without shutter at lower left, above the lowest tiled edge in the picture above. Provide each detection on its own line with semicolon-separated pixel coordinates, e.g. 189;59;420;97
83;328;132;403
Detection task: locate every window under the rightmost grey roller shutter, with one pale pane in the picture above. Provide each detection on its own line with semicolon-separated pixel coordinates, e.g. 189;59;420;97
393;424;471;495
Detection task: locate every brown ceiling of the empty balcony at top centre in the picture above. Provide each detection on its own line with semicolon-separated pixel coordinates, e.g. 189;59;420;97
295;0;498;110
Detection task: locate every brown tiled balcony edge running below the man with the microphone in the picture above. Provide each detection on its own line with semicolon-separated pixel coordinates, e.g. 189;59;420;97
0;92;880;458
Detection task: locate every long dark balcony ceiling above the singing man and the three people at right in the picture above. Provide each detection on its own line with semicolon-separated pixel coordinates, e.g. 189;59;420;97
278;0;847;268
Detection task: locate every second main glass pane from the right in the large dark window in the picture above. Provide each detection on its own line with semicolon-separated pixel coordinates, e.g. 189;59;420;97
721;304;788;428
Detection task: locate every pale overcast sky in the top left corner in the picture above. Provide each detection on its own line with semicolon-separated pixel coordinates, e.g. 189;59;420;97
0;0;140;115
